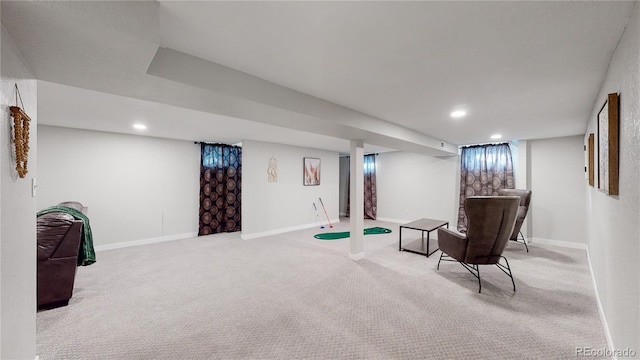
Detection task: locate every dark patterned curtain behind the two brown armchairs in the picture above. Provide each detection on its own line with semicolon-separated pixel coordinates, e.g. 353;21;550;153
458;143;515;232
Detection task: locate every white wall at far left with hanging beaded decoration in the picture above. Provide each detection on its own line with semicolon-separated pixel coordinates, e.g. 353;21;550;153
0;27;38;359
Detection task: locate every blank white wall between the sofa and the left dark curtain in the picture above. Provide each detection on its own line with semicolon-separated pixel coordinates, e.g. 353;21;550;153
38;126;200;248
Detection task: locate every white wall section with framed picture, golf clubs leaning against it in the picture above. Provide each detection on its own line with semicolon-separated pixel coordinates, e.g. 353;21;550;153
242;140;339;239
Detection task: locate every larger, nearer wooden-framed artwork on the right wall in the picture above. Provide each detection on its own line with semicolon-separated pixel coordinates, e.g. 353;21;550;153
598;94;620;195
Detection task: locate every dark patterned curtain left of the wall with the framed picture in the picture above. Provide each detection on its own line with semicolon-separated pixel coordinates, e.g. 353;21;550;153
198;144;242;236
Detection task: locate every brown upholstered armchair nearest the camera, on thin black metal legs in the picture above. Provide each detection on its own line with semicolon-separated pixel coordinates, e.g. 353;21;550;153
437;196;520;292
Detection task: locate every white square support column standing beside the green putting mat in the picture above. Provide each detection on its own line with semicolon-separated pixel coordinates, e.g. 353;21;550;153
349;140;364;260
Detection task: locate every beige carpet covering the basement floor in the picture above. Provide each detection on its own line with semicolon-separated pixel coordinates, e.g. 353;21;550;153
37;221;606;359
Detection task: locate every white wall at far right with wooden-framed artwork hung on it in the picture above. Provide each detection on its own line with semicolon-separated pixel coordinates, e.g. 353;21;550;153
582;4;640;353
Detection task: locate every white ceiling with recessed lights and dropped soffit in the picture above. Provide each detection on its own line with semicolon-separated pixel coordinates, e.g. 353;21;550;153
2;1;634;152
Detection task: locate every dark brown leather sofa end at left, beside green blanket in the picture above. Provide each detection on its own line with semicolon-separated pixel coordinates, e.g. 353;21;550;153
37;207;83;309
